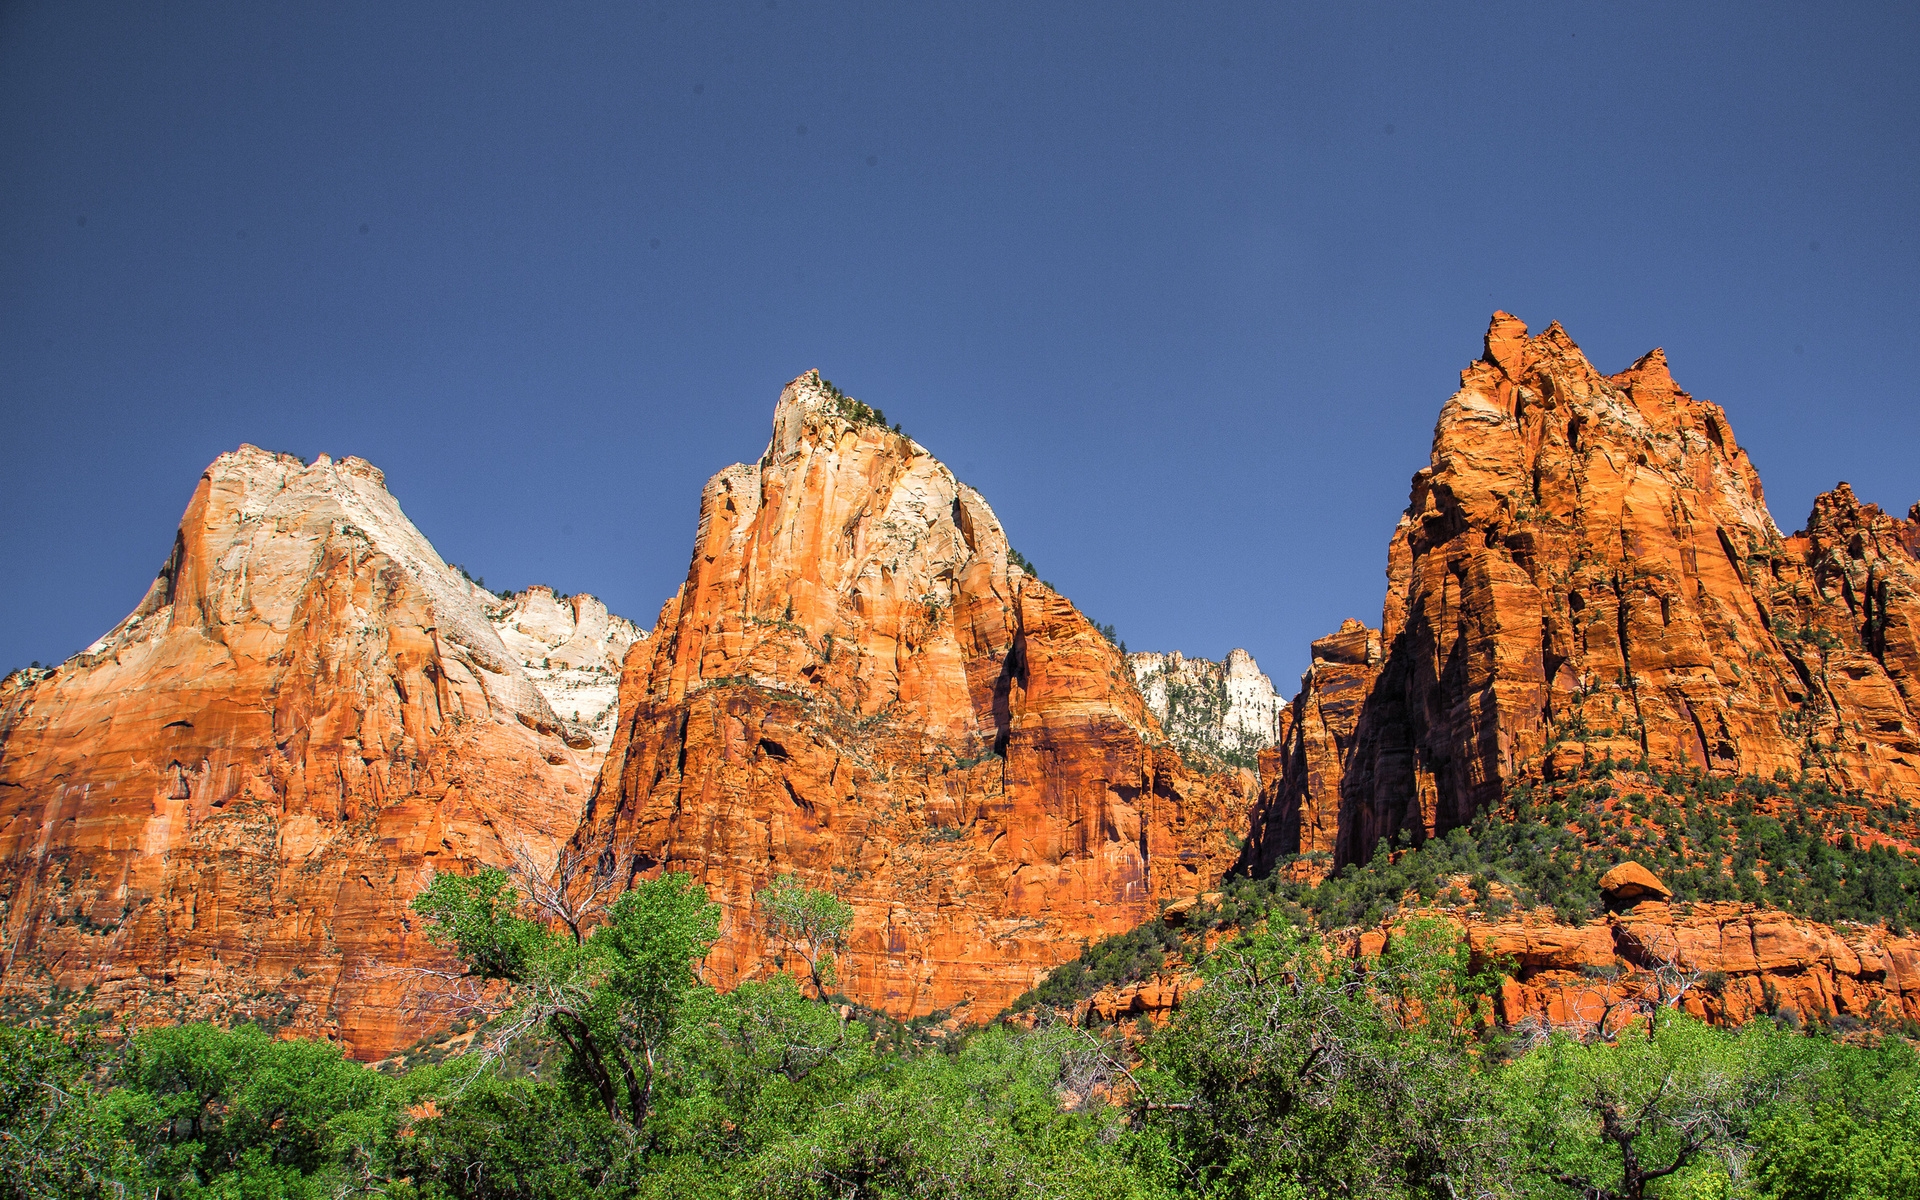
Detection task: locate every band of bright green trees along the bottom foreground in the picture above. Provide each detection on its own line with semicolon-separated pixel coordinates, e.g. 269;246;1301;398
11;872;1920;1200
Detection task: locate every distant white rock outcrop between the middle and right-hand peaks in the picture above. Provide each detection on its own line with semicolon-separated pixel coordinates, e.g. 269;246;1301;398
1127;649;1286;768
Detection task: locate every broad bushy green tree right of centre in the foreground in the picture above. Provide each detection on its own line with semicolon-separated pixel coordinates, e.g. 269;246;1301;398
1135;925;1492;1196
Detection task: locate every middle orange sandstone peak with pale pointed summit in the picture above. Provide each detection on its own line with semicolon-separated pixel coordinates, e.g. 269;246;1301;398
578;372;1252;1018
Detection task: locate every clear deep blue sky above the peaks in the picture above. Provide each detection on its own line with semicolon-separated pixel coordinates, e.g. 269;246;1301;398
0;0;1920;693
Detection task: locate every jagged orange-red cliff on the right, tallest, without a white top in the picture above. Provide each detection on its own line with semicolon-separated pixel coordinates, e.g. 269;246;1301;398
1254;313;1920;862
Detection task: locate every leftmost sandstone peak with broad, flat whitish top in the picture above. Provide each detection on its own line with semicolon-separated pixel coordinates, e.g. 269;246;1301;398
0;447;599;1058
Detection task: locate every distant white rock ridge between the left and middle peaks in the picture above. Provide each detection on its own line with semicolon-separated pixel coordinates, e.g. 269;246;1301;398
486;586;647;755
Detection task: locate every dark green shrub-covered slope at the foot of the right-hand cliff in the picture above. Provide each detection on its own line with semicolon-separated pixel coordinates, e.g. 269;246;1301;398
1012;762;1920;1012
